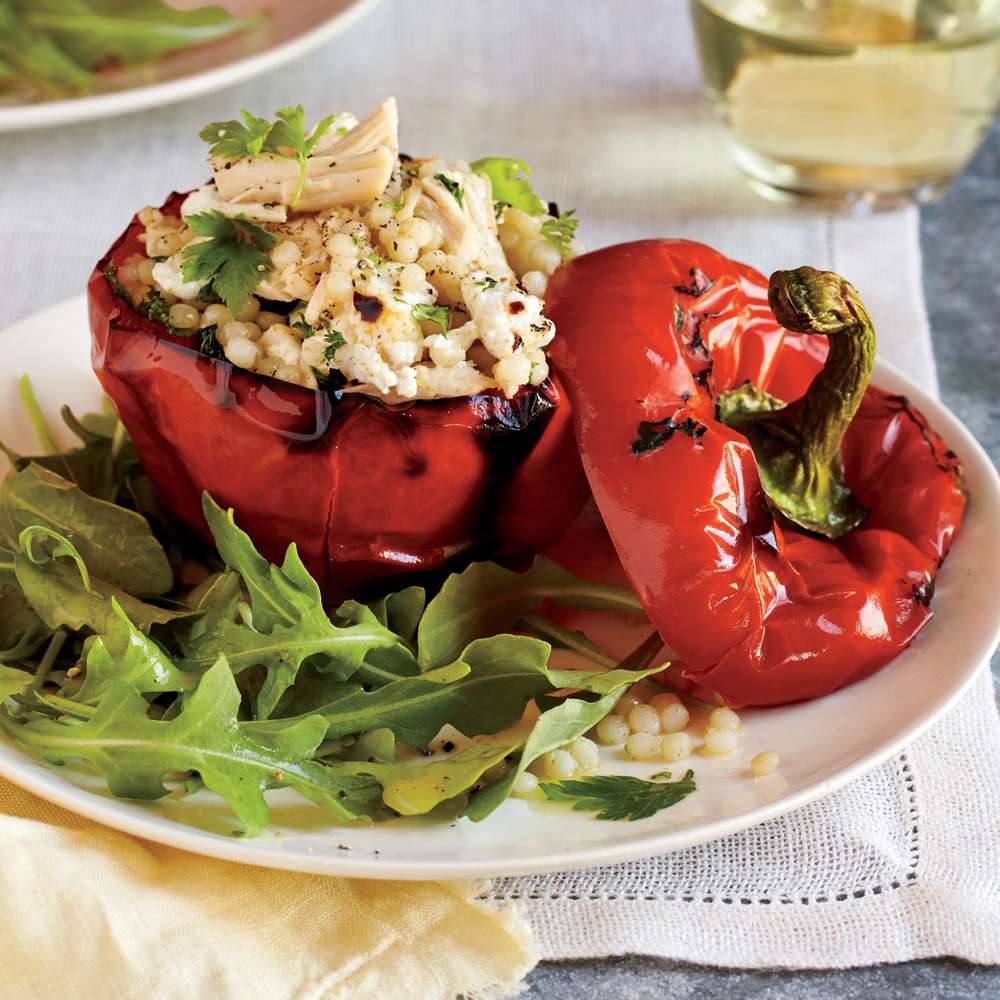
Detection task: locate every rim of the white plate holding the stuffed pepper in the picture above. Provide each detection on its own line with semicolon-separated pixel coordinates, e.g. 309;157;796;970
0;296;1000;881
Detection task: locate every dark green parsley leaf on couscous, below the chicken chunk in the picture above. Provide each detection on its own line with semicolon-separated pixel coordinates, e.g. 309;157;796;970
181;209;277;315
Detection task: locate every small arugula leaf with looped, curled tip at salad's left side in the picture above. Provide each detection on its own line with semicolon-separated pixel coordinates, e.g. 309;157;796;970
14;526;190;632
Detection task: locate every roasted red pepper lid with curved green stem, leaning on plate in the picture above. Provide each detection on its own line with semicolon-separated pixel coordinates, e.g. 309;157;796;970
550;240;966;706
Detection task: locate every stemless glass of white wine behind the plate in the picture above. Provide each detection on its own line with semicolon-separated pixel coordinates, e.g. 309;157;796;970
691;0;1000;212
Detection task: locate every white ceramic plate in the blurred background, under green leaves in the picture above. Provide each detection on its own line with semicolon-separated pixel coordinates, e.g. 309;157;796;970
0;0;379;132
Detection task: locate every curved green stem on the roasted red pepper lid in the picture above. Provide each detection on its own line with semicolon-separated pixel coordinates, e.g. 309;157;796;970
719;267;876;538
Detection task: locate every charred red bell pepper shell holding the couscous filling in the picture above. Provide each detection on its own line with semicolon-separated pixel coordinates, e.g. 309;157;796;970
88;195;588;602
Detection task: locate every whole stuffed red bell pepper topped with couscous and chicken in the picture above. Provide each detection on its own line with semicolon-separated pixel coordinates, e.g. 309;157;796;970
89;100;587;600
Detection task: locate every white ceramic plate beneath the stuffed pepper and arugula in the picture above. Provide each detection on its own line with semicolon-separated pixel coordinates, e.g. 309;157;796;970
0;297;1000;879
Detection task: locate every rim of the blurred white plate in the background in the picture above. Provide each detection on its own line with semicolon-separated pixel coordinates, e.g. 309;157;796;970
0;0;381;132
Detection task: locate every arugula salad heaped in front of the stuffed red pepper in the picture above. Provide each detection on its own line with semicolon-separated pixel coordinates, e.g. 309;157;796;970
0;380;695;835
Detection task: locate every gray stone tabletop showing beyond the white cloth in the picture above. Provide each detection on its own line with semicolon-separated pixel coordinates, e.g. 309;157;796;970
528;122;1000;1000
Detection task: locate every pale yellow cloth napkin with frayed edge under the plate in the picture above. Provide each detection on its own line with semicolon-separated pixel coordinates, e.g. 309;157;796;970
0;779;537;1000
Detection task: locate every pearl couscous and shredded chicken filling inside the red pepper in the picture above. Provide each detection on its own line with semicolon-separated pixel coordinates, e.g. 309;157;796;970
117;98;581;403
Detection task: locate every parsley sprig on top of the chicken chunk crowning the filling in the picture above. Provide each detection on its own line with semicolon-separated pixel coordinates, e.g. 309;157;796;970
199;104;339;208
